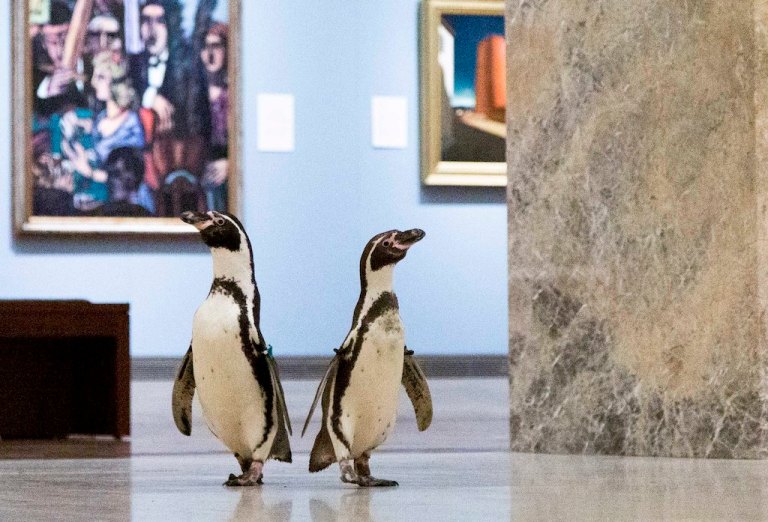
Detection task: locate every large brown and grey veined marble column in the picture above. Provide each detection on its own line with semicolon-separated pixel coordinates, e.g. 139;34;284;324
506;0;768;458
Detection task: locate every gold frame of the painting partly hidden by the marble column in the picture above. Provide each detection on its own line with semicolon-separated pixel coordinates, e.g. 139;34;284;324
420;0;507;186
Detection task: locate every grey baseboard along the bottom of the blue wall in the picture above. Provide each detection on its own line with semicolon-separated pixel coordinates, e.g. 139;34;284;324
131;355;509;381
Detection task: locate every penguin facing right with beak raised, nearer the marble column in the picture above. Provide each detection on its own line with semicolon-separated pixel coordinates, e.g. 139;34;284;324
302;229;432;487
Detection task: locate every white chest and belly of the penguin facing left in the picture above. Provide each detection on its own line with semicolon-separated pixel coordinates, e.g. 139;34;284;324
192;294;274;459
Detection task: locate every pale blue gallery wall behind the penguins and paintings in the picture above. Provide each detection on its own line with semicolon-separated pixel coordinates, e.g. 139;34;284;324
0;0;507;357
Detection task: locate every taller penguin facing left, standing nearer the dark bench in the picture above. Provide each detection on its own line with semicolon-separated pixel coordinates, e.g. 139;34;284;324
172;211;291;486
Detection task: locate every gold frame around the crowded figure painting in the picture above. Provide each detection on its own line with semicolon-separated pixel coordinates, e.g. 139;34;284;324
11;0;242;236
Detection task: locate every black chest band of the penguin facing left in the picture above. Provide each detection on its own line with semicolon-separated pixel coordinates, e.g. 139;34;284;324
210;277;275;450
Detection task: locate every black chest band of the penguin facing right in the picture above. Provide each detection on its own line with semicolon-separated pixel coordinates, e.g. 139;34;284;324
331;292;398;450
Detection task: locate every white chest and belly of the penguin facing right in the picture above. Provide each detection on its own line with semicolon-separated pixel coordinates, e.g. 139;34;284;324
341;310;405;456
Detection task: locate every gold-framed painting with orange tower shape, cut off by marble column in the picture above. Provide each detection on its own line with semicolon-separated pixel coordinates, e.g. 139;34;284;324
420;0;507;186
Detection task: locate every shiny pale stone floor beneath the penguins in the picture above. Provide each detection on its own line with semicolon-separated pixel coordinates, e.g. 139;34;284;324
0;379;768;521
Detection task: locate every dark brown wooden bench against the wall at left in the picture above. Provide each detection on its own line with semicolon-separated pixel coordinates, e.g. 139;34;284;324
0;300;130;439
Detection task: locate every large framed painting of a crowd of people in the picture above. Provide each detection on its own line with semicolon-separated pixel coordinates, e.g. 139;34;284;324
12;0;240;234
